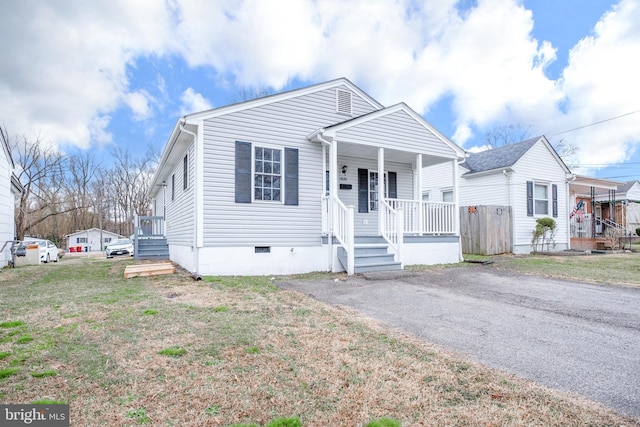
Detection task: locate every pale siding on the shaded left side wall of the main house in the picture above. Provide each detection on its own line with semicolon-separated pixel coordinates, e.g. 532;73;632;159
165;143;195;246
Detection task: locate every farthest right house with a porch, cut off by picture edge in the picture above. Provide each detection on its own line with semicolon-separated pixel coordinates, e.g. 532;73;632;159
594;181;640;234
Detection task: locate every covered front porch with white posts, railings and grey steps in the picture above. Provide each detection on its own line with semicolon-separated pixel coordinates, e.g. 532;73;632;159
309;105;461;274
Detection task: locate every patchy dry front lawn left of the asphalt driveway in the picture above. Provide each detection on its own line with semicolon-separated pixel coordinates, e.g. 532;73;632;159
0;259;640;426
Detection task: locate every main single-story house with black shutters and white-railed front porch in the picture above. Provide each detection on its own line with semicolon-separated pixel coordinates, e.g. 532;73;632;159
146;78;464;275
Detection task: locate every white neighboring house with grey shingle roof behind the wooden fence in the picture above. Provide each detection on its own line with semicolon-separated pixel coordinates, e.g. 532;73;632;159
423;136;572;254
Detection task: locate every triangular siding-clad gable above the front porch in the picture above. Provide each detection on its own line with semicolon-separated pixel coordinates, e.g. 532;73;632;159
337;111;455;158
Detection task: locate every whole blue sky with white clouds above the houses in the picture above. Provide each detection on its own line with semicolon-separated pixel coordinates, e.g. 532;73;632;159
0;0;640;180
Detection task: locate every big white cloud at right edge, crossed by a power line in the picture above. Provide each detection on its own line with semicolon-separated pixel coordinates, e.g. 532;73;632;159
557;0;640;174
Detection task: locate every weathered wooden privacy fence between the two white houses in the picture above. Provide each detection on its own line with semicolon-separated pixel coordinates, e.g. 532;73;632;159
460;205;513;255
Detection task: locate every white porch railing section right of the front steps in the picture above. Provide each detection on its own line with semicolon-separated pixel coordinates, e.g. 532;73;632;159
386;199;456;235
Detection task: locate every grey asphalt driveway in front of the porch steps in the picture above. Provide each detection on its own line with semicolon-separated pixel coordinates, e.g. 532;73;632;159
279;264;640;417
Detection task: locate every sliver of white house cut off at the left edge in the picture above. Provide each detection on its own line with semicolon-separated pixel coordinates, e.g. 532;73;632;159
0;132;24;267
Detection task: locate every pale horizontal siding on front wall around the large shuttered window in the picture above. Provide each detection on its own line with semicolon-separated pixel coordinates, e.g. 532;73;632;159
203;86;380;247
